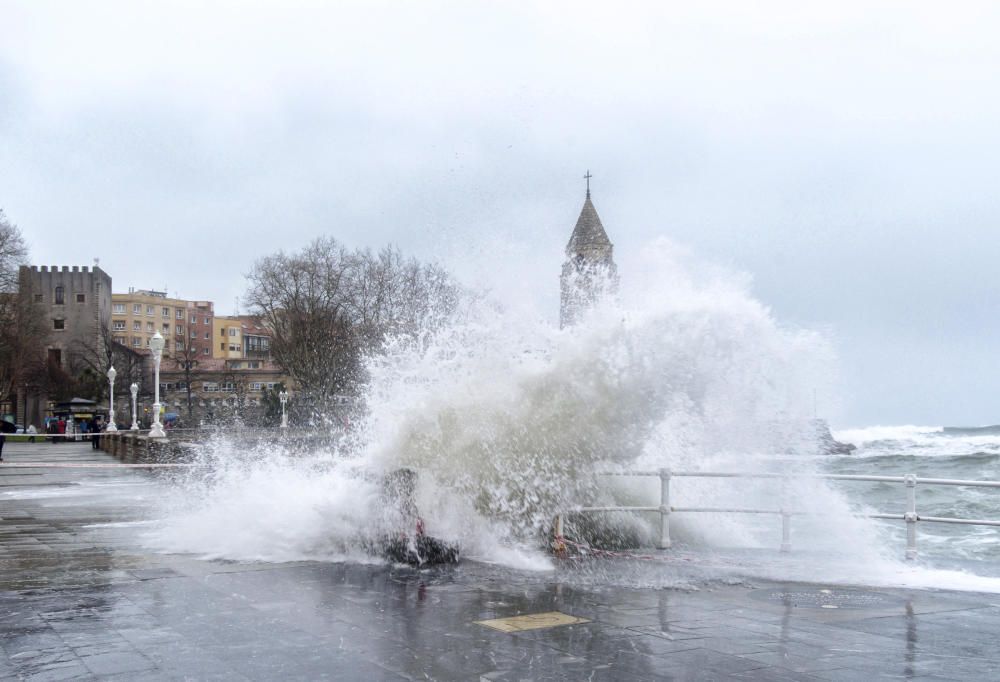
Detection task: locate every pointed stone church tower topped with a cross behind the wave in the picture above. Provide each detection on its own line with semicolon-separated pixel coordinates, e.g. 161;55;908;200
559;171;618;328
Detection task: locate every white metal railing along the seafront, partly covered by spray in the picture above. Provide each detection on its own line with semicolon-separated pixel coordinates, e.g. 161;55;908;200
556;469;1000;559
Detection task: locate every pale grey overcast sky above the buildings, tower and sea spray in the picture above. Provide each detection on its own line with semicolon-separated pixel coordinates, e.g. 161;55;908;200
0;0;1000;426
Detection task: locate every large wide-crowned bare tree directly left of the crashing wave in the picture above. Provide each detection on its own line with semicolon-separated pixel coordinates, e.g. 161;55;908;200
244;237;458;404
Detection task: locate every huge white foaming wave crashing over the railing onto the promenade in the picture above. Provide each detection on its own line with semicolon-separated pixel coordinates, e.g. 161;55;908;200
144;240;1000;591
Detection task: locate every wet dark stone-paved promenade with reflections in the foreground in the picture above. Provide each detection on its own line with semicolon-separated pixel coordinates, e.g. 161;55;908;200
0;443;1000;681
